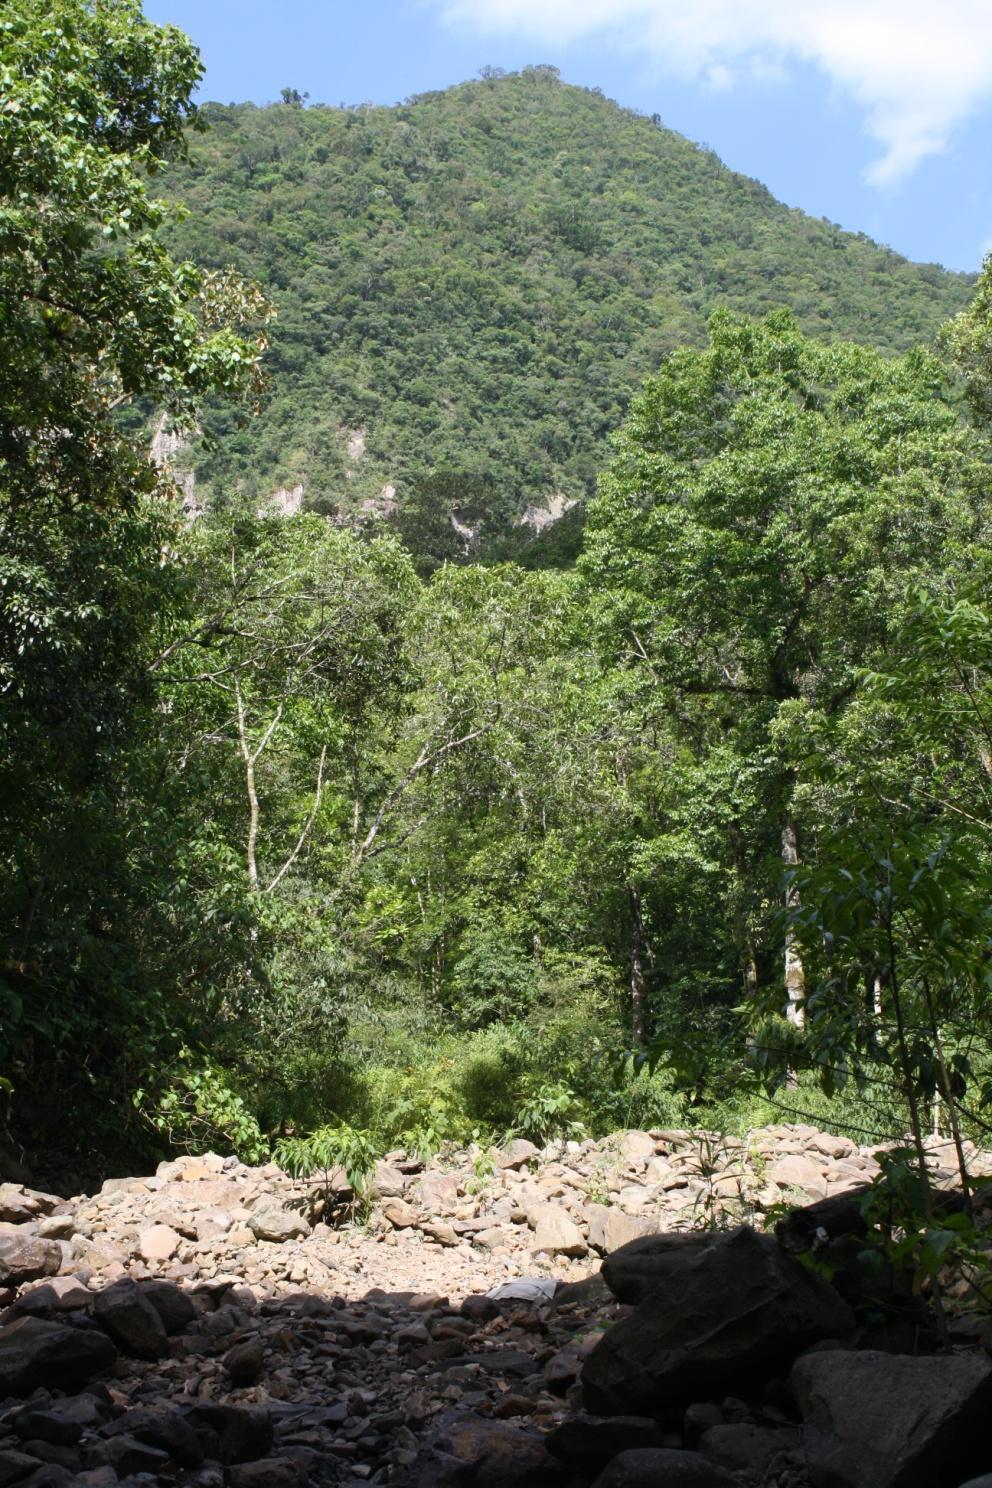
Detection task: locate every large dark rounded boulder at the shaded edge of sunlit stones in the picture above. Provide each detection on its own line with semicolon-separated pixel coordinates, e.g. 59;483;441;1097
582;1228;854;1415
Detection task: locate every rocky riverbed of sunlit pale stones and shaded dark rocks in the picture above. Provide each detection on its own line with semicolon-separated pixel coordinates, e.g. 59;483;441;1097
0;1126;992;1488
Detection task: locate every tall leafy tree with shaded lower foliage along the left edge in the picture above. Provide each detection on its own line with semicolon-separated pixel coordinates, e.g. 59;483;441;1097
0;0;266;1160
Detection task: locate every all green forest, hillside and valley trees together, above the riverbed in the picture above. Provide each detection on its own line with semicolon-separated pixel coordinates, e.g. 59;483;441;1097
0;0;992;1243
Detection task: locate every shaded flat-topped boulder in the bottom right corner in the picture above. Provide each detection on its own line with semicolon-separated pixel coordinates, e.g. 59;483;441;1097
791;1351;992;1488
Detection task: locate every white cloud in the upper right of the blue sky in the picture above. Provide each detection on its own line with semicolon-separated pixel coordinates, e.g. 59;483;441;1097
433;0;992;186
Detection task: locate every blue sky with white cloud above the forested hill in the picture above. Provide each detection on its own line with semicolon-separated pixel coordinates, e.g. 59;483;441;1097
146;0;992;269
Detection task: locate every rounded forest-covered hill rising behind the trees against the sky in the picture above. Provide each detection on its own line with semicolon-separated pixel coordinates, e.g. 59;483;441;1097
167;67;970;557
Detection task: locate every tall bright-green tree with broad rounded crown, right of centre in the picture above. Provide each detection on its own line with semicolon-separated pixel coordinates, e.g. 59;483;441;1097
583;312;986;1021
